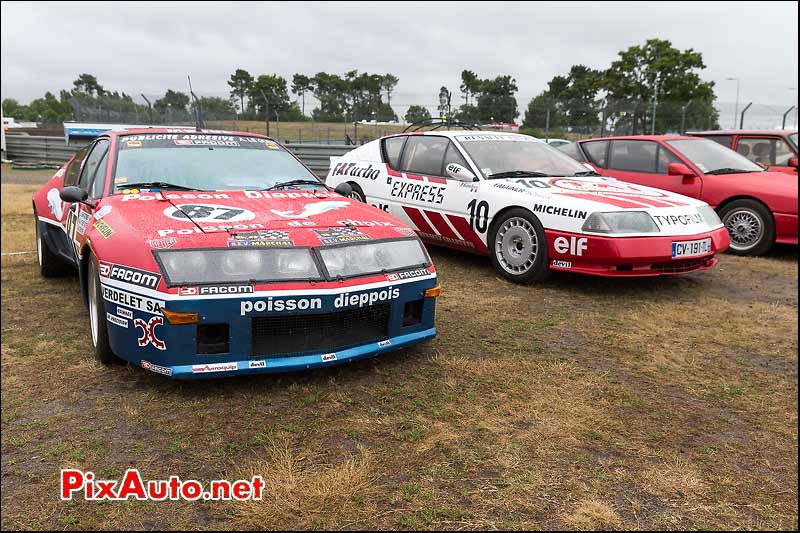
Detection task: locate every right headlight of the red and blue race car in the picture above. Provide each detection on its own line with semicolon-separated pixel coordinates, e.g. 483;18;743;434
317;239;428;278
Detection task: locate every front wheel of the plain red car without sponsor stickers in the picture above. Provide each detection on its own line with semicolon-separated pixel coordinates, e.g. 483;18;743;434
719;199;775;255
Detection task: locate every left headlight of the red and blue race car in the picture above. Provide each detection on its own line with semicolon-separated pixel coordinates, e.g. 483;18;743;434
155;248;322;287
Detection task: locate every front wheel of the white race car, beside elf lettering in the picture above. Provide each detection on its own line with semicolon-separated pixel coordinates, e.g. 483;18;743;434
489;207;550;283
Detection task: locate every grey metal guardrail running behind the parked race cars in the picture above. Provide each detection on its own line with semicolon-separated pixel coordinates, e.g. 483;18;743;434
6;135;355;176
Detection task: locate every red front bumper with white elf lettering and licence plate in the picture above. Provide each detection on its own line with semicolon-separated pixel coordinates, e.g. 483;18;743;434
545;227;730;277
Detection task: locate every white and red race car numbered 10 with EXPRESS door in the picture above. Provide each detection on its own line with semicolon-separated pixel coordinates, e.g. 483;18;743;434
326;131;730;282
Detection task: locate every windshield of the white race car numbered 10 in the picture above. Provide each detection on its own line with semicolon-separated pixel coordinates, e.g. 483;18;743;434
456;134;588;178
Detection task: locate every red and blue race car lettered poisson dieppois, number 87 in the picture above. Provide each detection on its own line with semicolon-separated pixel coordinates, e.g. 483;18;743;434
33;128;439;378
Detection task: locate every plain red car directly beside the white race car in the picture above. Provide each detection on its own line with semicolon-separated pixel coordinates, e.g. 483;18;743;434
559;135;797;255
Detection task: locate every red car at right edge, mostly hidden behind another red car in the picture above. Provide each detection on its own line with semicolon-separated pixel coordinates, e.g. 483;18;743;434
686;130;797;175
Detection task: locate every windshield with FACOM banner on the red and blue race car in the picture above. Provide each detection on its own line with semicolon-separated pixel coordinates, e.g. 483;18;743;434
114;133;321;191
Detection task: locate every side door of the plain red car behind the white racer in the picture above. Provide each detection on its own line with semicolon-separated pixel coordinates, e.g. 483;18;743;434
606;139;702;198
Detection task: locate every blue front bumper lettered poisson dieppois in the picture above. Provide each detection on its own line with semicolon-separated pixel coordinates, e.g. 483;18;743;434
103;277;436;379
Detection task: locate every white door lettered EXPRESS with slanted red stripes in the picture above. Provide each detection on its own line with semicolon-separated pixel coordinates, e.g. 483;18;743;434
390;135;485;251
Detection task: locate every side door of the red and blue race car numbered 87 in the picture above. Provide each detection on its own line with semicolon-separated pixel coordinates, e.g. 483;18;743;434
64;138;110;257
